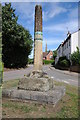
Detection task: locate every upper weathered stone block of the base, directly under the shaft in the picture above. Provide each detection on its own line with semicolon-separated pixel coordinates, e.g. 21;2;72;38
18;71;53;91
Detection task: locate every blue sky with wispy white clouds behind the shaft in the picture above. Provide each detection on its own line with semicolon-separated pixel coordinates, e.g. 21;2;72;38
1;2;78;57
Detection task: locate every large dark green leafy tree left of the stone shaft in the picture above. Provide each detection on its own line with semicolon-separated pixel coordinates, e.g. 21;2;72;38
2;3;33;68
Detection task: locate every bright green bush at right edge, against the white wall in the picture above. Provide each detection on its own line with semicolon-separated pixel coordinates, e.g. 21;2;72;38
71;47;80;65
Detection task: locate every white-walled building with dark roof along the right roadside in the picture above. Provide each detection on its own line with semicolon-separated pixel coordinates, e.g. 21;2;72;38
55;30;80;64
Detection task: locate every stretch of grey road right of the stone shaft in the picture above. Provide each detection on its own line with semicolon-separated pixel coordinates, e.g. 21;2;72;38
44;66;80;86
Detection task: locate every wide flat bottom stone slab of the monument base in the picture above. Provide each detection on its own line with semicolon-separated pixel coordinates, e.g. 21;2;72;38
2;86;65;105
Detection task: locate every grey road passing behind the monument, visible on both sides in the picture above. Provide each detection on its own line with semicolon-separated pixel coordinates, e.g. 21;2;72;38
3;65;80;86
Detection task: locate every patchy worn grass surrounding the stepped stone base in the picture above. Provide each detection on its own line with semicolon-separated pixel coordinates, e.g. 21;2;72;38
2;80;78;118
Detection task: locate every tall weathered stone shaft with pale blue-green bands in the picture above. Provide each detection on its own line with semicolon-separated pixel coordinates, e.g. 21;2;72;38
34;5;43;71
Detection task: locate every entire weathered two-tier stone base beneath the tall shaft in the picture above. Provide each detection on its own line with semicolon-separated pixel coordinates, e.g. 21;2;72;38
2;71;65;105
